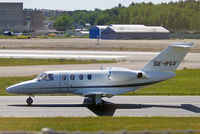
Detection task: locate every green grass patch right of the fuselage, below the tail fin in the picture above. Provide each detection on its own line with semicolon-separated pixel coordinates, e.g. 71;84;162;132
125;69;200;95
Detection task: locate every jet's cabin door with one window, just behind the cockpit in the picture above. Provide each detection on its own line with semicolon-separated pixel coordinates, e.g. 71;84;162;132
60;73;69;93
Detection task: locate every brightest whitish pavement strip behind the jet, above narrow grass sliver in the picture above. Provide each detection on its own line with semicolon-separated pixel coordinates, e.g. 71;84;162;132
0;49;158;60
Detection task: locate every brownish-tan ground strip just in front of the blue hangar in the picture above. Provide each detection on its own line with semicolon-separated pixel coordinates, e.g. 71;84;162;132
0;38;200;53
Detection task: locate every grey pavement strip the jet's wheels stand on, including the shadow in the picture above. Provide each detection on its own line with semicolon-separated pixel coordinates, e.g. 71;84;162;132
0;96;200;117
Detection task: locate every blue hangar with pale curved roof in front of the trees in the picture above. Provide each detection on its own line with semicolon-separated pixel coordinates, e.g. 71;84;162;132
90;25;170;40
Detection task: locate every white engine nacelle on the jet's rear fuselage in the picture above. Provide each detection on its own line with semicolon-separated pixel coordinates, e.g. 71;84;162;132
109;71;143;81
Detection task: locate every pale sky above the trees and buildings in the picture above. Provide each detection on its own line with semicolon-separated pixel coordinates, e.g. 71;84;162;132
0;0;178;11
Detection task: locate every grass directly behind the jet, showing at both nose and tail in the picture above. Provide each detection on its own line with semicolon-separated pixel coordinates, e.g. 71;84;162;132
0;69;200;96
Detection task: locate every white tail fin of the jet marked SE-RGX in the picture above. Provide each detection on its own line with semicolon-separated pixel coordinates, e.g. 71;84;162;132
141;43;193;72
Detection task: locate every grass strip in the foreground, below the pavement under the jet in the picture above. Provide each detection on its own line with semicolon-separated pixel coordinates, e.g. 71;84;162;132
0;117;200;131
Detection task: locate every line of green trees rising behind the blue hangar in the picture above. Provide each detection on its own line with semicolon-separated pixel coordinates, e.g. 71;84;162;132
52;0;200;30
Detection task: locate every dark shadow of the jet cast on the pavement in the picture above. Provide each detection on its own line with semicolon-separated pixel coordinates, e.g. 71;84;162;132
8;98;200;116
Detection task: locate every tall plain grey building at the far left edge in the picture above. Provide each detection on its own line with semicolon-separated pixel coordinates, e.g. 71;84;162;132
0;3;25;32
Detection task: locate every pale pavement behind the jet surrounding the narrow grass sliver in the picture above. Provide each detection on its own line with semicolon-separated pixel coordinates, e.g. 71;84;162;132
0;50;200;77
